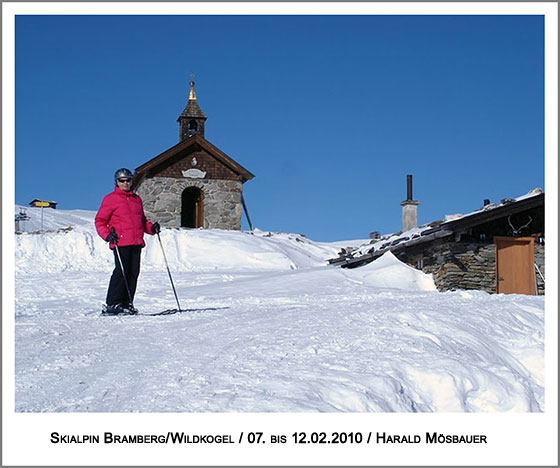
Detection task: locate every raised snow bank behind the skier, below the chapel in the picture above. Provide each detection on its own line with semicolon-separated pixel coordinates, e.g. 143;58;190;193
15;206;337;273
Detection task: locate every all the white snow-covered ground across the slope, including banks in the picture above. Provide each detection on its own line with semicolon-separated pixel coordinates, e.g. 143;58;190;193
15;207;545;412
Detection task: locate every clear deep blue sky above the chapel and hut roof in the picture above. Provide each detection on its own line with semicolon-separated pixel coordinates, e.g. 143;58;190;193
15;15;544;241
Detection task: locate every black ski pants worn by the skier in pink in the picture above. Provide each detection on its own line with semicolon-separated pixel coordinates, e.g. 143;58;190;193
107;245;142;307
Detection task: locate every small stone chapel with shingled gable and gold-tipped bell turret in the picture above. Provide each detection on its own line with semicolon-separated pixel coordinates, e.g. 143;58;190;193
133;81;254;230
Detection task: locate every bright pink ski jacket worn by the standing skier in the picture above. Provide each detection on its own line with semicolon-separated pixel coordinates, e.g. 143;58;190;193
95;187;153;249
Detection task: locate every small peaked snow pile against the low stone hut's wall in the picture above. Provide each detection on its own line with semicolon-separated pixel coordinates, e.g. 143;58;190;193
346;251;437;291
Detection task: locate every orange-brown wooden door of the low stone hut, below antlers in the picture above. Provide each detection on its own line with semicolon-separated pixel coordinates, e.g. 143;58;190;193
494;237;535;295
